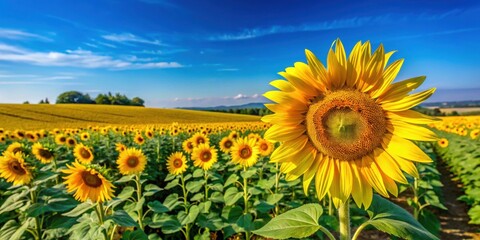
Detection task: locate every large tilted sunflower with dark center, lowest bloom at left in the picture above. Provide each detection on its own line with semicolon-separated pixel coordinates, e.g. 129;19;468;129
62;162;115;202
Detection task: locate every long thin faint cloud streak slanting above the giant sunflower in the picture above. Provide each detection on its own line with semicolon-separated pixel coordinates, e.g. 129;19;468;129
207;9;462;41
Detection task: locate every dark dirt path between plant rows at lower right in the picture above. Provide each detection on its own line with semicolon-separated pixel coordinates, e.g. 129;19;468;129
437;160;480;240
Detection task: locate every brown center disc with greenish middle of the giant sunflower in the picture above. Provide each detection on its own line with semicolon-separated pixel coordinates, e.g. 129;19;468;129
306;90;387;160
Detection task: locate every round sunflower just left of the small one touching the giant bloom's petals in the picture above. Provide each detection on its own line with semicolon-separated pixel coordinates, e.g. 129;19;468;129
230;137;259;167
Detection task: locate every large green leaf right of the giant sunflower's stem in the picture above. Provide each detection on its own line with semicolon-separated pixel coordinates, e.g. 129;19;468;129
367;194;438;240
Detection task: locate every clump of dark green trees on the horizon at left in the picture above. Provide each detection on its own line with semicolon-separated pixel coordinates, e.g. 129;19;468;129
56;91;145;107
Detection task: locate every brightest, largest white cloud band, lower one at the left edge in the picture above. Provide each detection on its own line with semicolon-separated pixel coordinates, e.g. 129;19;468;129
0;43;183;70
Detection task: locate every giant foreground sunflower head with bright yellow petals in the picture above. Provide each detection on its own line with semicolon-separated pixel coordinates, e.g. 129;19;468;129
262;40;437;209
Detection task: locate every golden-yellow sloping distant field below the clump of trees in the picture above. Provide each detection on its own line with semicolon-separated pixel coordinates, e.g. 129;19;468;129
0;104;260;130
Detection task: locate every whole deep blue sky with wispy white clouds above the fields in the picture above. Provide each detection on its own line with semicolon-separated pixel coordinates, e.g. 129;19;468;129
0;0;480;107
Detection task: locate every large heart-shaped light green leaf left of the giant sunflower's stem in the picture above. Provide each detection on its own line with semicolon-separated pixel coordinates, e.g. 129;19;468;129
253;204;323;239
